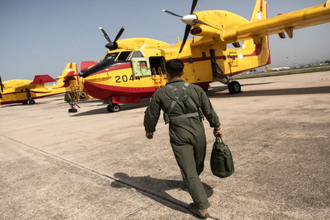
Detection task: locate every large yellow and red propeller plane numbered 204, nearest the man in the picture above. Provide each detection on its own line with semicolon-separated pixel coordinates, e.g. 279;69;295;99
80;0;330;112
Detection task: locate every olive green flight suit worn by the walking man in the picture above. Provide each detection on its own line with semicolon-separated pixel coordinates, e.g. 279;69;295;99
144;79;220;209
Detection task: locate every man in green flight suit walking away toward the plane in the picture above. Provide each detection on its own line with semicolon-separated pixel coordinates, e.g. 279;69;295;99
144;59;222;218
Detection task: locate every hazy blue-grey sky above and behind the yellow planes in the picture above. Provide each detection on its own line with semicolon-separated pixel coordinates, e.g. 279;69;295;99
0;0;330;80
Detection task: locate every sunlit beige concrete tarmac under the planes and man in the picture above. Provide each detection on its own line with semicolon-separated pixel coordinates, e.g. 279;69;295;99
0;72;330;220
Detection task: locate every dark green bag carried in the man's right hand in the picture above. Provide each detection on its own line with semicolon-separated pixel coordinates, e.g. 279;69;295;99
211;136;235;178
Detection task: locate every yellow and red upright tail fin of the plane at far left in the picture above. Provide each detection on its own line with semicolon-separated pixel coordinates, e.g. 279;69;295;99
55;63;79;87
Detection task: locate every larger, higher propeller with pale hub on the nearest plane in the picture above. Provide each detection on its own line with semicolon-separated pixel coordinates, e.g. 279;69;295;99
163;0;219;53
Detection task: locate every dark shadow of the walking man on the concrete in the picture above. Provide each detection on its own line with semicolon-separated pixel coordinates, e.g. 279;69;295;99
111;173;213;216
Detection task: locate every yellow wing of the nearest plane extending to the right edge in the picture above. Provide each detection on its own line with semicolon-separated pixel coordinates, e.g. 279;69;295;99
220;0;330;44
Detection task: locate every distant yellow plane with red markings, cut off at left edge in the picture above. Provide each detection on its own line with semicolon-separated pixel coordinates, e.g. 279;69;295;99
0;63;79;105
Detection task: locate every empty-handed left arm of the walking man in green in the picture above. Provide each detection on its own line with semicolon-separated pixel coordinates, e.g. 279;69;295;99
143;93;161;139
